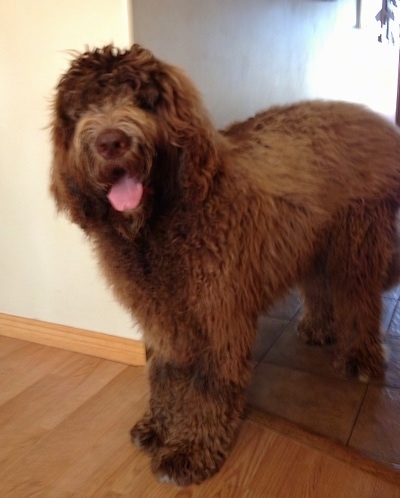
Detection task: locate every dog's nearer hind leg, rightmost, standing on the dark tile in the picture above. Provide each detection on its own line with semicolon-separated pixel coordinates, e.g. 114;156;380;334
328;203;395;381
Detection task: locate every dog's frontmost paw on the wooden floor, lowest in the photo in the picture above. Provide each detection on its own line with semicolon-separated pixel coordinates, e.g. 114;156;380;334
152;448;226;487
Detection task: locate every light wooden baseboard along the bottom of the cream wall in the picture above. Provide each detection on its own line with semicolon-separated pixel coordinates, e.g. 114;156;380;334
0;313;146;366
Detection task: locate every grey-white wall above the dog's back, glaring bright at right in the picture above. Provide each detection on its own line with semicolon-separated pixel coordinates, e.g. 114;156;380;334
132;0;398;126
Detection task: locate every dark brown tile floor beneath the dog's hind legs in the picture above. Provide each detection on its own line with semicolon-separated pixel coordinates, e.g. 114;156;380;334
249;286;400;469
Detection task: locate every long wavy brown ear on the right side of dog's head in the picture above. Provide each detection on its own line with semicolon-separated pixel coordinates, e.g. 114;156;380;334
126;45;218;200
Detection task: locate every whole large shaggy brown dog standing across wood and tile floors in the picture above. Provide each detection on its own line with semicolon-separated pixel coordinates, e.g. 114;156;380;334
51;45;400;486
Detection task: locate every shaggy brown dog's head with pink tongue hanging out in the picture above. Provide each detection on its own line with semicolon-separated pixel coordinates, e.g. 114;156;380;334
51;45;217;237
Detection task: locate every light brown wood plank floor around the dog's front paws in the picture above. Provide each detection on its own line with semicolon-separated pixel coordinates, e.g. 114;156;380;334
0;337;400;498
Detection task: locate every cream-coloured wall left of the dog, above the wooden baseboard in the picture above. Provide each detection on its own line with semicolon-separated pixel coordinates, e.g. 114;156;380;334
0;0;143;338
